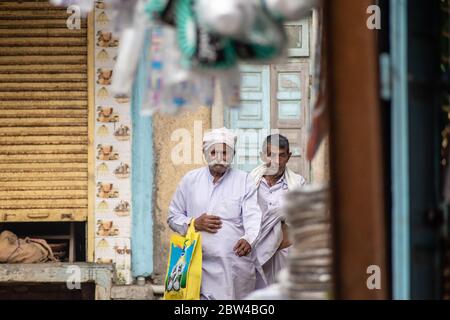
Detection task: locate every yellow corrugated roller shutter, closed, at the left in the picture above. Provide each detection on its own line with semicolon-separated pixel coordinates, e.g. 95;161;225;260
0;0;88;222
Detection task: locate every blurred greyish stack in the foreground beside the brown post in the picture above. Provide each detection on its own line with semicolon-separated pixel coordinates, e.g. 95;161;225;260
247;185;333;300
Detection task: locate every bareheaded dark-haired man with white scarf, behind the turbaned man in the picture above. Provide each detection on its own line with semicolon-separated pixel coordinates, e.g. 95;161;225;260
251;134;306;289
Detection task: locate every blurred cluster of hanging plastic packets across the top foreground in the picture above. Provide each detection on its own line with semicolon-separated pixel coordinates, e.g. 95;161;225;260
50;0;320;115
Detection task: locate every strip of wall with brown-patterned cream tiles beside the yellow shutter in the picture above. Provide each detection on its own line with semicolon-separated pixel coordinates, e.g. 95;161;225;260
94;1;132;284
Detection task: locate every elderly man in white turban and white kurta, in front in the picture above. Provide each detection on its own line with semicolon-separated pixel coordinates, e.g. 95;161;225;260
167;128;262;299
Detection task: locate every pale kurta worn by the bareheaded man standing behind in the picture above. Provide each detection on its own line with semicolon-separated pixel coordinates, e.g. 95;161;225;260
256;171;306;289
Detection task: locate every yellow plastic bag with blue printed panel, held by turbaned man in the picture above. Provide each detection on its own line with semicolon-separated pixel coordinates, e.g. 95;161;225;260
164;222;202;300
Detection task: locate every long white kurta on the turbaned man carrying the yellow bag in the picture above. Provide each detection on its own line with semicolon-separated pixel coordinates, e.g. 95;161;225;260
167;167;262;299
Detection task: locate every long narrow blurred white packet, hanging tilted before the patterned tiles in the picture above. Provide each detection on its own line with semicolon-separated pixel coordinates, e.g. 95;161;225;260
111;0;150;95
